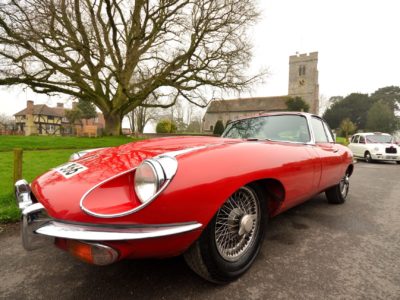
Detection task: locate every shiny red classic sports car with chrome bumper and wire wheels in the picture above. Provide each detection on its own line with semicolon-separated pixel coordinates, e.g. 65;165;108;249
16;112;353;283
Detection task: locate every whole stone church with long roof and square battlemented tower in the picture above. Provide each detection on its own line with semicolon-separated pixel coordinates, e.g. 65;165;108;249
203;52;319;131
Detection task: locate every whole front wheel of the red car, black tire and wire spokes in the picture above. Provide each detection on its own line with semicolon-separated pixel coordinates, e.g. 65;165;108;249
184;186;268;284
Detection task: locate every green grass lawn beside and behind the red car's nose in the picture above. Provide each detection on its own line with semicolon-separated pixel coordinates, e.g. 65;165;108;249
0;136;142;223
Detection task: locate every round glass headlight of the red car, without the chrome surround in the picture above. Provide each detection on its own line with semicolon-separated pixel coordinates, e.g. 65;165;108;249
135;160;165;203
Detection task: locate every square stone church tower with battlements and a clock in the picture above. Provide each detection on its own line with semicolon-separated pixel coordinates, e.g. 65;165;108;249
289;52;319;114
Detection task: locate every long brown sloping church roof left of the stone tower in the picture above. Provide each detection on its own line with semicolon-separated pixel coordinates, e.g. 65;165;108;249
207;96;289;113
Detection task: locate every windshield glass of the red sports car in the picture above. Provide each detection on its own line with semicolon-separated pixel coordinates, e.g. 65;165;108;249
222;115;310;143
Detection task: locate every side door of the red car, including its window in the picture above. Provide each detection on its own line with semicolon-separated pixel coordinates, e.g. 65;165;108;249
311;116;343;190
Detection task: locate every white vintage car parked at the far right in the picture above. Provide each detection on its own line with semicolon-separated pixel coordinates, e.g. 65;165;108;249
348;132;400;164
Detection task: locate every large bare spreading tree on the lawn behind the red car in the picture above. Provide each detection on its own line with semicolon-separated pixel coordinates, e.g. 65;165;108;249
0;0;262;135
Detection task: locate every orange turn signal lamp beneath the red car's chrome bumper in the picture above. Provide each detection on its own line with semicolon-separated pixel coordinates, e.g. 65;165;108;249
67;240;118;266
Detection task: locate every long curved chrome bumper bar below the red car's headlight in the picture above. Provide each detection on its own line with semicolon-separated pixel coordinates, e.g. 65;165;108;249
36;221;202;241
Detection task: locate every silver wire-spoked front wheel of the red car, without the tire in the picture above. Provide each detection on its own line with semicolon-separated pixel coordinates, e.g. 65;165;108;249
215;186;261;262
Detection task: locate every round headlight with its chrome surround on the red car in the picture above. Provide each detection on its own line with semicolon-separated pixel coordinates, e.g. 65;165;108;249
134;156;178;204
